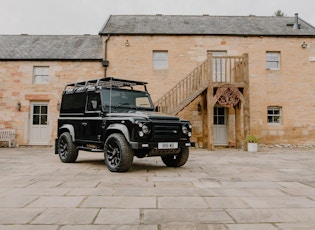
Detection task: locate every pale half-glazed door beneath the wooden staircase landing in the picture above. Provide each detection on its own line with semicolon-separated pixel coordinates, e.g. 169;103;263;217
213;107;228;146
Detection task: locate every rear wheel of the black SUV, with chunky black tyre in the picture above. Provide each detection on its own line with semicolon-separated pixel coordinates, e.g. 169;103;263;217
58;132;79;163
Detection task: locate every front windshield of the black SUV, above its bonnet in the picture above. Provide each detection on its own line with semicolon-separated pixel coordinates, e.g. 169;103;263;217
102;88;153;112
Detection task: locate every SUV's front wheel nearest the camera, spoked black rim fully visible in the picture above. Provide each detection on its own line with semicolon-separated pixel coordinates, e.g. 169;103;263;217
104;133;134;172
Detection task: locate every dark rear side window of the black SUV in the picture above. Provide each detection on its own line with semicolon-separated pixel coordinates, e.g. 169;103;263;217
60;93;86;113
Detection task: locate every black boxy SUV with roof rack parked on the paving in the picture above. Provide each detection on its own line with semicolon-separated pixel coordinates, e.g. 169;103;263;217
55;77;194;172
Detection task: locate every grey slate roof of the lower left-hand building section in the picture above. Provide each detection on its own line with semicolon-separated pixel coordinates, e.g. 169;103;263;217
0;35;102;60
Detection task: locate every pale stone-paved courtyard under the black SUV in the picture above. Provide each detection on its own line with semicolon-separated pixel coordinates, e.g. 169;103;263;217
0;148;315;230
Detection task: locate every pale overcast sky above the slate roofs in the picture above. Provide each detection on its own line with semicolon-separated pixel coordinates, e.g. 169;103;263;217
0;0;315;35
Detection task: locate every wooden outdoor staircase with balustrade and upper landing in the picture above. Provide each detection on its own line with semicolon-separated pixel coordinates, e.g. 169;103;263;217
155;53;248;115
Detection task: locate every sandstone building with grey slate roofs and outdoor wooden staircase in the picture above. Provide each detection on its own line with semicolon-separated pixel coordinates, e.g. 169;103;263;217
0;15;315;149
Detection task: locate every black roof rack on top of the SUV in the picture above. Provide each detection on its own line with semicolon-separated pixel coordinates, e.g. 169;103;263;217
64;77;148;94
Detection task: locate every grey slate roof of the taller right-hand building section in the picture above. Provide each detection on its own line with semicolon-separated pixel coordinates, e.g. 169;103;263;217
99;15;315;36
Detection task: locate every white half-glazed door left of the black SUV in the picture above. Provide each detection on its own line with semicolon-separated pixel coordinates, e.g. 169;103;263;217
29;102;49;145
